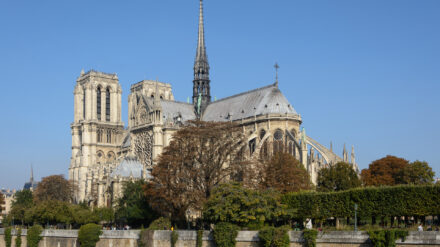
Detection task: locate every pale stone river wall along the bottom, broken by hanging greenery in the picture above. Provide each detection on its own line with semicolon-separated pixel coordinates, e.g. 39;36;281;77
0;229;440;247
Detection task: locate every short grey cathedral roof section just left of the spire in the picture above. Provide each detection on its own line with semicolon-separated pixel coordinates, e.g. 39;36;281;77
160;100;196;122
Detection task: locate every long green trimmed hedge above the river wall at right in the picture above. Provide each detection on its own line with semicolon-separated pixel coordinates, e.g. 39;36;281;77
282;185;440;219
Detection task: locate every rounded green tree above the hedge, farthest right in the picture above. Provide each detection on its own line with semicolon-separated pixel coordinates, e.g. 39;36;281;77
403;160;435;184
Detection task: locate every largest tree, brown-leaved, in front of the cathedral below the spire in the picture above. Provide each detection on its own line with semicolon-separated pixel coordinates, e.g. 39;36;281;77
145;121;246;220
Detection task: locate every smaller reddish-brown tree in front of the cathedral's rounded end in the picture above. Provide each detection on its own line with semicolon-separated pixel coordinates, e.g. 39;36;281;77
262;152;312;193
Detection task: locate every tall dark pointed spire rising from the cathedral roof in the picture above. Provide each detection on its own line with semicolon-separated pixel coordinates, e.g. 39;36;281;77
192;0;211;117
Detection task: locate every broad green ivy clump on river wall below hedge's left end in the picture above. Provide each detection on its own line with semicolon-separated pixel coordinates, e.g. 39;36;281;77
258;226;290;247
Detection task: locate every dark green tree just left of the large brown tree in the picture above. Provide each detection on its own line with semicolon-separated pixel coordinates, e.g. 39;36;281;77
116;180;157;227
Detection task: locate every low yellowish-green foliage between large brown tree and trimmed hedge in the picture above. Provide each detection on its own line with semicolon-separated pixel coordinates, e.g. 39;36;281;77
203;184;288;227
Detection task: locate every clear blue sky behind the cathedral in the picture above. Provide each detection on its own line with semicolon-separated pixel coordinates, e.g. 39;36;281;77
0;0;440;188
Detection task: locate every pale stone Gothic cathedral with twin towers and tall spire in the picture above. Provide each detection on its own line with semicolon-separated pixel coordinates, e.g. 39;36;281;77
69;0;358;207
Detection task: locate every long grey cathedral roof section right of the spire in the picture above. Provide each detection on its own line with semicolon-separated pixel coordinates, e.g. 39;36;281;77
202;84;297;121
